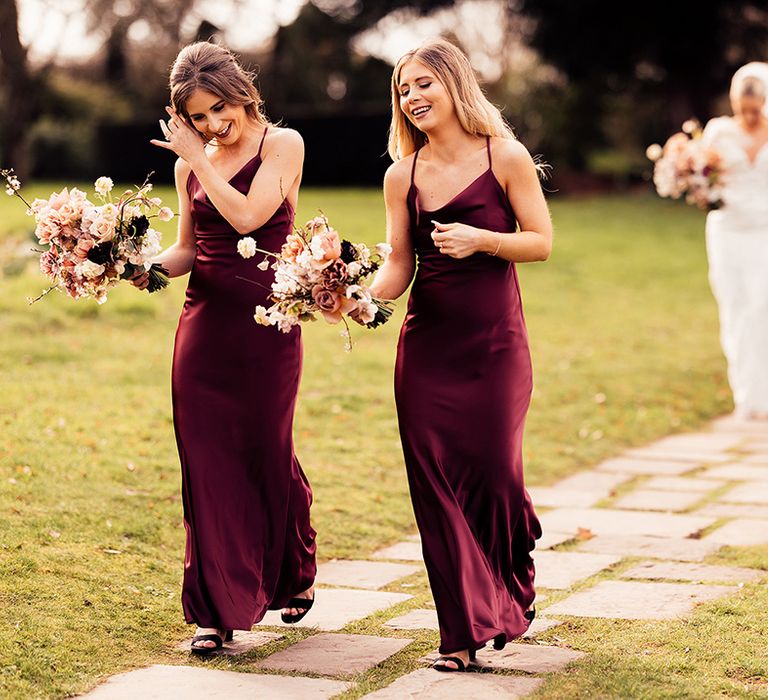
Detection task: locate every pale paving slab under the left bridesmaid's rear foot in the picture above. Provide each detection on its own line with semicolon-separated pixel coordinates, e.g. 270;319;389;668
259;588;413;632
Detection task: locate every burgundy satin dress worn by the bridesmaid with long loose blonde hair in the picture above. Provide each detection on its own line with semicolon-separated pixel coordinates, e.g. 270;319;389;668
395;141;541;654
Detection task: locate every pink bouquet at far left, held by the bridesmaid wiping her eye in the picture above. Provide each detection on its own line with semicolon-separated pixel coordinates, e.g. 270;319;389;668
0;170;173;304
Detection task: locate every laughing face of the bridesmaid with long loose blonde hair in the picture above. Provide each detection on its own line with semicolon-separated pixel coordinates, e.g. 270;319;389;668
397;59;456;132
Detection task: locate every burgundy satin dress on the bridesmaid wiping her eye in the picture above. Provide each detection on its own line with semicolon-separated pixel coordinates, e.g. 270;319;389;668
172;131;316;630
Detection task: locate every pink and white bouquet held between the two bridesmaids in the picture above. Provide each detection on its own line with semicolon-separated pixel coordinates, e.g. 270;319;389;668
237;216;392;349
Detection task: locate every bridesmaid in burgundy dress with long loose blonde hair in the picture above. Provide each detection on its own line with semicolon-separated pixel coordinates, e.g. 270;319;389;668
371;40;552;671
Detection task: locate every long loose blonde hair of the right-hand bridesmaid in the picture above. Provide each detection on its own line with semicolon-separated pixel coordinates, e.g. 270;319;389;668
387;39;516;160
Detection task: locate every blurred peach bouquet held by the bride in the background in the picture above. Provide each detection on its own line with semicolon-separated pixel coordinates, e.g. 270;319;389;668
645;119;724;210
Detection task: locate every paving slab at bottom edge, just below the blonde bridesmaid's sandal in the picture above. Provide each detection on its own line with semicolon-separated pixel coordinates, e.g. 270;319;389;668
363;668;544;700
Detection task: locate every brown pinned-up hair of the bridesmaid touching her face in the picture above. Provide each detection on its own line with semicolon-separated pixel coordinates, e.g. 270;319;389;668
169;41;269;138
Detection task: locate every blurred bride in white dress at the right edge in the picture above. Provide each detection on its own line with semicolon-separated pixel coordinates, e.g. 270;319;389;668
704;62;768;419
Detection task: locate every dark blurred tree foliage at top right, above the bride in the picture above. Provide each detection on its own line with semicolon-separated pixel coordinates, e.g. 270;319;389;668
508;0;768;167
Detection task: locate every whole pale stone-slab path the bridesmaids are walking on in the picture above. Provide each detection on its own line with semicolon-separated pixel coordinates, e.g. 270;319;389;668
84;418;768;700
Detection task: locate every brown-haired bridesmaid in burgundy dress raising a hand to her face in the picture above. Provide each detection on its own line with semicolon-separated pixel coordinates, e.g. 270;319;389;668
134;43;315;654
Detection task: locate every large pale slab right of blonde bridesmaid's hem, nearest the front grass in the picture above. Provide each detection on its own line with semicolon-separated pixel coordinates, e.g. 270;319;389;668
547;581;738;620
